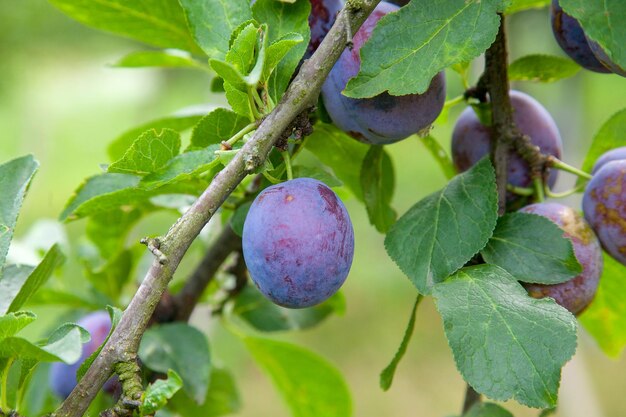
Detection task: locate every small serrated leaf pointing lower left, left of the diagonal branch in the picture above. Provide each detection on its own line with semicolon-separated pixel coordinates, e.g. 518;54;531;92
59;173;141;220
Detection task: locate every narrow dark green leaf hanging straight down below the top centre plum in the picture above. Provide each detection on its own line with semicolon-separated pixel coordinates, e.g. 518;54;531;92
361;145;398;233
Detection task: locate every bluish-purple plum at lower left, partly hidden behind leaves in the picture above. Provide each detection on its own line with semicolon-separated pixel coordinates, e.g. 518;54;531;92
48;311;119;398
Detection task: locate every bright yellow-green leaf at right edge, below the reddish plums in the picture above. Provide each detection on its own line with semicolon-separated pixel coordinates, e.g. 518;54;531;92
579;254;626;358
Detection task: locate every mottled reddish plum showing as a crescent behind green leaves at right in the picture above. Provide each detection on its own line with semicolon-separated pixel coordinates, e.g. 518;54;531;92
520;203;604;315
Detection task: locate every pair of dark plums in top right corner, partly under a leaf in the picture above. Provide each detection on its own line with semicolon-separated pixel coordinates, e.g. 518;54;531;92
550;0;626;77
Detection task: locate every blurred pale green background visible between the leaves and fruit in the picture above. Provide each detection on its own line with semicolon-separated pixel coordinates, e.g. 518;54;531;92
0;0;626;417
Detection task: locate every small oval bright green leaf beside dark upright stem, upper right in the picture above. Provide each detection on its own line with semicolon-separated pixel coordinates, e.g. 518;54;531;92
509;54;580;83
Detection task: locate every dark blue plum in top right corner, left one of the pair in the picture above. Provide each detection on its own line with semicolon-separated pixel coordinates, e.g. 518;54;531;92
550;0;611;73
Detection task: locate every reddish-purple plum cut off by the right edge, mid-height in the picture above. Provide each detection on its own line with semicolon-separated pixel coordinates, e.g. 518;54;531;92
583;160;626;265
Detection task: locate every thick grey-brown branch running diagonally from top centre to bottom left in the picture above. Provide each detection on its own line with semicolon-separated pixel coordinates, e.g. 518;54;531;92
53;0;380;417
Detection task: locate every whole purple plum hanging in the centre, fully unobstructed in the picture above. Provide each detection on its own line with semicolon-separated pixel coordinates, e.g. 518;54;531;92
242;178;354;308
